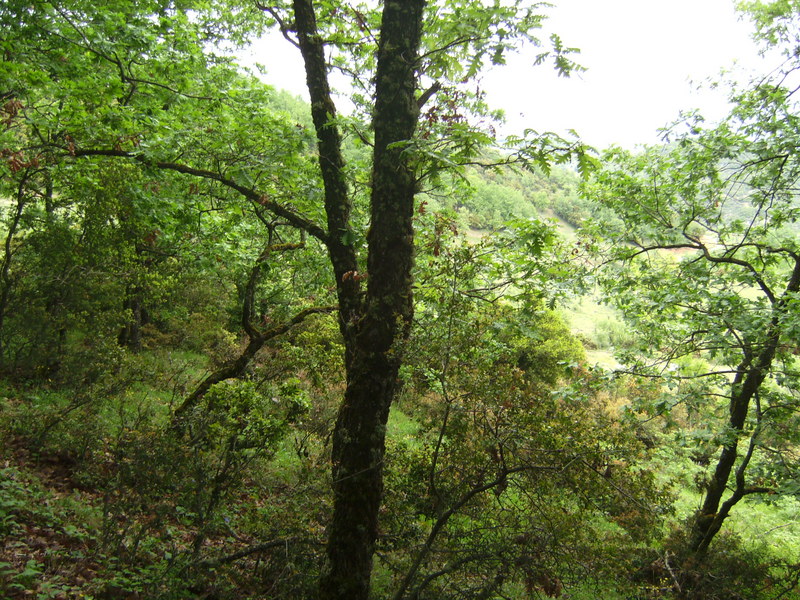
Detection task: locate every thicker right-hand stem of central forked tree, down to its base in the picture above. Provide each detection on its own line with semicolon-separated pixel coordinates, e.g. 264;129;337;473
320;0;425;600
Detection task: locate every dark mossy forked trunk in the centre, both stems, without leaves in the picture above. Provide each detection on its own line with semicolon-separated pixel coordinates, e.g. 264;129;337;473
294;0;425;600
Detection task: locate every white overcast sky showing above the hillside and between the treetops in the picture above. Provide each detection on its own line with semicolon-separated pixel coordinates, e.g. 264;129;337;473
245;0;759;148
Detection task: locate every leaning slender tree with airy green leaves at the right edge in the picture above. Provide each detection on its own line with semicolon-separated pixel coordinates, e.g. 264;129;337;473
588;3;800;553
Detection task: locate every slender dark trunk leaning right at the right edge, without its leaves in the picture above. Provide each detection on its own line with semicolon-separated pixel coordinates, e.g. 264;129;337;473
689;257;800;553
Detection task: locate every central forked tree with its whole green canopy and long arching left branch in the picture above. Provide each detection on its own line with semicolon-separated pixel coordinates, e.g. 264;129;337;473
2;0;587;599
